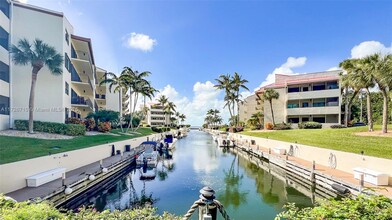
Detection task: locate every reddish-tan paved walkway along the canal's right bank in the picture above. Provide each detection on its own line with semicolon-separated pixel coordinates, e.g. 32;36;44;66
242;142;392;199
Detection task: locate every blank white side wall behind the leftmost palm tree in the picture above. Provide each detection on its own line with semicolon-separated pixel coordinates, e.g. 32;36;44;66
11;3;67;126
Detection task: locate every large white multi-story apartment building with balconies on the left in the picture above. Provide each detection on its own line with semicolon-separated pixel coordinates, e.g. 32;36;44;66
0;0;121;129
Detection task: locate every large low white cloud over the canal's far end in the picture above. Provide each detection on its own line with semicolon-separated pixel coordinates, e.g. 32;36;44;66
155;81;229;125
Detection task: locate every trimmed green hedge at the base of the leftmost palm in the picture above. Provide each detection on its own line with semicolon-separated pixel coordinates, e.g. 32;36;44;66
15;120;86;136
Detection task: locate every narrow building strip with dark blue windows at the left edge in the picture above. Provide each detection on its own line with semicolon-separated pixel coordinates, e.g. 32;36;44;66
0;0;10;130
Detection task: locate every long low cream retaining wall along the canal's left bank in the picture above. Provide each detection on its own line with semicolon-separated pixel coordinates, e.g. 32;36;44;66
0;134;160;193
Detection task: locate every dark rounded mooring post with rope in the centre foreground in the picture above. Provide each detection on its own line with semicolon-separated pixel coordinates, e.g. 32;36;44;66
199;186;217;220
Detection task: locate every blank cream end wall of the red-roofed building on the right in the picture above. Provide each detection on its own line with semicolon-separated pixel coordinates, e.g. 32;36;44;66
264;88;287;123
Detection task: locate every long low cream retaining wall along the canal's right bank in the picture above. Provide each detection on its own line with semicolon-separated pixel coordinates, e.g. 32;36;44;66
232;134;392;185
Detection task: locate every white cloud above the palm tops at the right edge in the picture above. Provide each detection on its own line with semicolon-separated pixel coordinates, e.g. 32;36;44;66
351;41;392;58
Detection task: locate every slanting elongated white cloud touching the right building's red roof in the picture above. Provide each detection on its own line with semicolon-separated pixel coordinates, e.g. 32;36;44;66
255;57;307;91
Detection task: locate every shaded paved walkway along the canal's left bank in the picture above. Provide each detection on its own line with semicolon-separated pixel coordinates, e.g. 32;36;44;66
7;150;137;202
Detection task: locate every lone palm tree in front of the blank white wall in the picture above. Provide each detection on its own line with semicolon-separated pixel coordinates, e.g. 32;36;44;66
11;38;63;133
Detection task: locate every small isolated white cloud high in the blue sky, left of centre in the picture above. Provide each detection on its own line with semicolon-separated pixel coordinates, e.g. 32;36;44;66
125;32;157;52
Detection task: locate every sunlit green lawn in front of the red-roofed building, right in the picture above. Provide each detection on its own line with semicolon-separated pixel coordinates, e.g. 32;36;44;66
242;125;392;159
